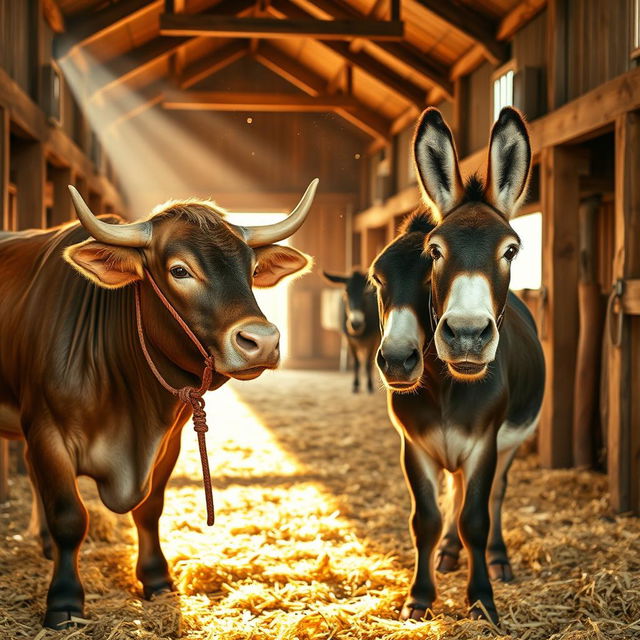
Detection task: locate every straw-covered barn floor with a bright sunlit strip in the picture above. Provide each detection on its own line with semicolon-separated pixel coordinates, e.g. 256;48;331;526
0;371;640;640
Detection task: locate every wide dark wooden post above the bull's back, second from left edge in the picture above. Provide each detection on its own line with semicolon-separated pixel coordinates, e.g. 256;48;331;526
13;141;46;229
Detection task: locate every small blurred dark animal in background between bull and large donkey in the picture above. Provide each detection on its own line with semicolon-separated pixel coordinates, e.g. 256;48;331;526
322;269;380;393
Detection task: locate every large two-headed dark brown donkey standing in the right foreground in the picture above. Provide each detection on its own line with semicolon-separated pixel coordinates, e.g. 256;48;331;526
370;108;545;624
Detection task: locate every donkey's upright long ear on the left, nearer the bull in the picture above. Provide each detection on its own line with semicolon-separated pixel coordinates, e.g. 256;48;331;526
413;107;464;222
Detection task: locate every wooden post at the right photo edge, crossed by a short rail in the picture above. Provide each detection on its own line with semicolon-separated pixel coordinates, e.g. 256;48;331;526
605;112;640;513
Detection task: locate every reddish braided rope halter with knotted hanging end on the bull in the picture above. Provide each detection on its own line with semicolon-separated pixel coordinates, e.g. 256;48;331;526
135;269;215;526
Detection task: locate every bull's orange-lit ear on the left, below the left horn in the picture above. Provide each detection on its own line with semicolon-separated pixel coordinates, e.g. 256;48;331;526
63;239;144;289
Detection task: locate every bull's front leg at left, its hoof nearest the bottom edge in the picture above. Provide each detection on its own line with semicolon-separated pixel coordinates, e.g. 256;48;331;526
25;420;89;629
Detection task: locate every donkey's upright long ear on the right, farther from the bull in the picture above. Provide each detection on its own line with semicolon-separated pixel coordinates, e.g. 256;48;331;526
485;107;531;218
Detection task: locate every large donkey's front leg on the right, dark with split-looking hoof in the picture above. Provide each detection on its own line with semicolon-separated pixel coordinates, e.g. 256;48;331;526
459;434;498;624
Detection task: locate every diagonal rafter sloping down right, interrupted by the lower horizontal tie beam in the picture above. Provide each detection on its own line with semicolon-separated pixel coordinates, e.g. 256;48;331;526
255;43;390;141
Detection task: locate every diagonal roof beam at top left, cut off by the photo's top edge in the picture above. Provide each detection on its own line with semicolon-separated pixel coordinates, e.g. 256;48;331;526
53;0;162;59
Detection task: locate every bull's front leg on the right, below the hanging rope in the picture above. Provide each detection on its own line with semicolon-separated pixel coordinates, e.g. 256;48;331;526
132;425;182;598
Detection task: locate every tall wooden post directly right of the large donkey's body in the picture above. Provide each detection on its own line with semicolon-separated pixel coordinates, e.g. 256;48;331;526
538;147;582;467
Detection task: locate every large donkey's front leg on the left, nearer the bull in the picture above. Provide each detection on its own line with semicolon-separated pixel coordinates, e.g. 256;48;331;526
400;438;442;620
